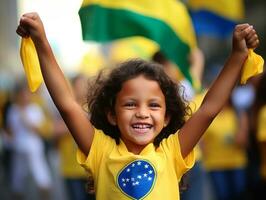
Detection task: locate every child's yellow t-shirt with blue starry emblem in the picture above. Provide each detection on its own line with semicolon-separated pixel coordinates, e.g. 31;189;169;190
77;130;195;200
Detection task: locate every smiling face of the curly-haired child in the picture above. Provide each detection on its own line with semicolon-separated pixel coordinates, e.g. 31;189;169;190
108;76;169;154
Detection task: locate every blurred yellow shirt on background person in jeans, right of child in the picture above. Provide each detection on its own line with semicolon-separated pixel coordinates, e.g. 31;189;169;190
202;108;247;170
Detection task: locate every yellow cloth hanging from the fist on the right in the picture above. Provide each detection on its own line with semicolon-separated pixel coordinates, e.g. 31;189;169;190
240;49;264;84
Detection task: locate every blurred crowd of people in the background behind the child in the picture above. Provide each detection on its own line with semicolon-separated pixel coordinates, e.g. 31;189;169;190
0;0;266;200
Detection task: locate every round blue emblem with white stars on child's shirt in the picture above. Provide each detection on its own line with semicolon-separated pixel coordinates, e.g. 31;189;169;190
117;160;156;199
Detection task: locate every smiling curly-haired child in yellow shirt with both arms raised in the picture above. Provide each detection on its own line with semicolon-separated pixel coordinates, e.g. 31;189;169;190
17;13;258;199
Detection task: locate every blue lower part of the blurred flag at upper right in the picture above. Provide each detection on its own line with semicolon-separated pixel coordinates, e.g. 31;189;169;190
190;10;237;38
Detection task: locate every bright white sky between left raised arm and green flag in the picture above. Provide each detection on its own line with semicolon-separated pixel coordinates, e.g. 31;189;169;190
18;0;99;73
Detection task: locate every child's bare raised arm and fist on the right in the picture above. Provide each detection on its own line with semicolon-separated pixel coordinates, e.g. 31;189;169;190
179;24;259;157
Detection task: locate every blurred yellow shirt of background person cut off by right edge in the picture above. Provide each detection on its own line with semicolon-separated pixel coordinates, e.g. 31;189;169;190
257;106;266;180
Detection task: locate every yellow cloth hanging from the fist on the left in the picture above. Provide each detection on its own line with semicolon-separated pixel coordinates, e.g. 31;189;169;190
20;37;43;92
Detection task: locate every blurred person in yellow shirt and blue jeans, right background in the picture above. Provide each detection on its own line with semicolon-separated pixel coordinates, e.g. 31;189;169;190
201;99;248;200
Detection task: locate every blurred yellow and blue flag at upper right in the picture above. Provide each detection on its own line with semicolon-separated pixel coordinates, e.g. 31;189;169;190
187;0;245;38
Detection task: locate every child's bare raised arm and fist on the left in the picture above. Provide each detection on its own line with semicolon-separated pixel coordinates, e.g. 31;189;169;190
17;13;94;154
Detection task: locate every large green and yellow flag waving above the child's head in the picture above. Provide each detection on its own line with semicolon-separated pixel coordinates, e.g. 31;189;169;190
79;0;196;82
